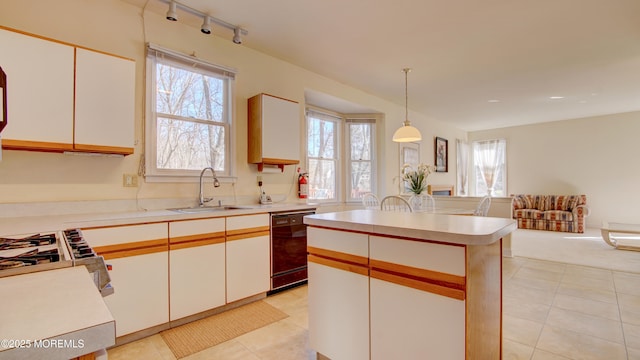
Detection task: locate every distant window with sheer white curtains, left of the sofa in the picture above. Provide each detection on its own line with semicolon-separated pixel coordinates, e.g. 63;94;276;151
473;139;507;196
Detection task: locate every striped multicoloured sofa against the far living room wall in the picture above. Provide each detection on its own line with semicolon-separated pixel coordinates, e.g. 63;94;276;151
511;194;589;233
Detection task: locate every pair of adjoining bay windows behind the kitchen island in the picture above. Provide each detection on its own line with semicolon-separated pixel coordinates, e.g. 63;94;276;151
307;109;376;202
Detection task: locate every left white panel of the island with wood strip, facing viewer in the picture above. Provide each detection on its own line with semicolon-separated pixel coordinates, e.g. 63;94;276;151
307;227;368;360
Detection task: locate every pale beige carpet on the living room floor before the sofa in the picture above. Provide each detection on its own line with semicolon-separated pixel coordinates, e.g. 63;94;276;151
511;229;640;273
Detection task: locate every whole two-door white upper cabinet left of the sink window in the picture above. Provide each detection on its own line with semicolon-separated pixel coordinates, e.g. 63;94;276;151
0;29;135;155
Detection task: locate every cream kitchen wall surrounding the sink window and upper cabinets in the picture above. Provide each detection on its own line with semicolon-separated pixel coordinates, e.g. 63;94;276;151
0;0;466;208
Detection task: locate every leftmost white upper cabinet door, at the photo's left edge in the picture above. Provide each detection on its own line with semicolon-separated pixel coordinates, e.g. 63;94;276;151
0;30;74;150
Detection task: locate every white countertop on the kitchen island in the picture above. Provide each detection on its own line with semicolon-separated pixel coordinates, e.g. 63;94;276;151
304;210;517;245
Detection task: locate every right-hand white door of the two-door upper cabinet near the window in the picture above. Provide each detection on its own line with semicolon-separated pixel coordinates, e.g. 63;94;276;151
74;49;136;152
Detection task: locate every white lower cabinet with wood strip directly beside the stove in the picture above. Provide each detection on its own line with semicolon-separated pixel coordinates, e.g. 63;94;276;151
82;222;169;337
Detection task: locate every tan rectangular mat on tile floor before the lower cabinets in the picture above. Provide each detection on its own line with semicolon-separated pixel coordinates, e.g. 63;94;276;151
160;301;289;359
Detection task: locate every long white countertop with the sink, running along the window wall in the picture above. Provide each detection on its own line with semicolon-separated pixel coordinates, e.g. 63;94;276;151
0;204;316;236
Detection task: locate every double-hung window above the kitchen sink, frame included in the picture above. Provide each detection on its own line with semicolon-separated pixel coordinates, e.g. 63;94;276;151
146;45;235;177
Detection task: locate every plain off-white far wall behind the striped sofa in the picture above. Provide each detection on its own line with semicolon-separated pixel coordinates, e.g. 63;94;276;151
469;112;640;227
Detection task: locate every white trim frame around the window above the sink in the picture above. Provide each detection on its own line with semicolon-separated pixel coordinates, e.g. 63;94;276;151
141;43;237;183
